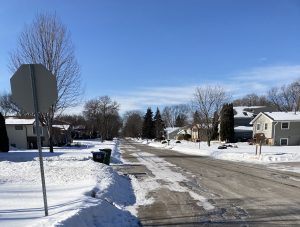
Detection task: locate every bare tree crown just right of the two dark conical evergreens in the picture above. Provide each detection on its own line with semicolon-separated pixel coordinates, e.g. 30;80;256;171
162;104;190;128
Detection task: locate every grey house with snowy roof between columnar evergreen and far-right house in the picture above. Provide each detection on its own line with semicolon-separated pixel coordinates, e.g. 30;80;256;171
233;106;274;141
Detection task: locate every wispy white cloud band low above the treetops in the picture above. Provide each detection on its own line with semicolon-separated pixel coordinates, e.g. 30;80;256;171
113;65;300;112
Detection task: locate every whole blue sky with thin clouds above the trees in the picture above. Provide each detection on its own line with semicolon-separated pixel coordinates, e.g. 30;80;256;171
0;0;300;111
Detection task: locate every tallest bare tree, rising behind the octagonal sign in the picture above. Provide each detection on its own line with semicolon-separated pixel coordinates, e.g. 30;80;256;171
10;14;82;152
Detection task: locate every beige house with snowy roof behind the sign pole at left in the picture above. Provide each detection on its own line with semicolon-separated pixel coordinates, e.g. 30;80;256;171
5;117;47;150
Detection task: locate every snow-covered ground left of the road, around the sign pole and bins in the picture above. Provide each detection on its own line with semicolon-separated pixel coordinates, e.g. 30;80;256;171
0;141;138;227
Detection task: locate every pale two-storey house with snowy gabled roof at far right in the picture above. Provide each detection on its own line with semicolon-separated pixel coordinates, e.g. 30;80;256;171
250;112;300;146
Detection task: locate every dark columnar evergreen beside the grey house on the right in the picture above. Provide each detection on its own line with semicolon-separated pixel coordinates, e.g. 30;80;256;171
220;103;234;142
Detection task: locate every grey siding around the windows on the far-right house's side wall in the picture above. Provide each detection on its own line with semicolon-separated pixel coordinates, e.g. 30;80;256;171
274;121;300;146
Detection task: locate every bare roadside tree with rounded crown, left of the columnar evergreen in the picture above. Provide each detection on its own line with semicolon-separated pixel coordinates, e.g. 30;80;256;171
192;86;229;146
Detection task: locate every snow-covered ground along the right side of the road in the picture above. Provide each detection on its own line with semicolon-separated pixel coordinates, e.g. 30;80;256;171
135;140;300;173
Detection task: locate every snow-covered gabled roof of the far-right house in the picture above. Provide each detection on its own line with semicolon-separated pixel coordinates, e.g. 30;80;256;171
250;112;300;124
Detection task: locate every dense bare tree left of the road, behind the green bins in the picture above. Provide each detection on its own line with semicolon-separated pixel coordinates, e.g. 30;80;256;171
83;96;122;140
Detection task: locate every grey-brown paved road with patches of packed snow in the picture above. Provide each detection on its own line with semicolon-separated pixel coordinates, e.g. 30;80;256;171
121;140;300;226
